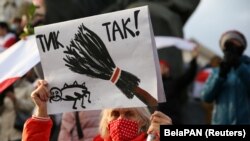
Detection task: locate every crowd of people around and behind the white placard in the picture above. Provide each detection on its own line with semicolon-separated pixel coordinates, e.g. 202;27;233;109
0;0;250;141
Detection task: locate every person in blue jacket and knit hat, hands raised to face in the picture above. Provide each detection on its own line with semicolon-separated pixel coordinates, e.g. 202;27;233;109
201;30;250;125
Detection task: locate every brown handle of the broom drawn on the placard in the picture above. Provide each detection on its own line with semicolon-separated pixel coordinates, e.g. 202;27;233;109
135;87;157;106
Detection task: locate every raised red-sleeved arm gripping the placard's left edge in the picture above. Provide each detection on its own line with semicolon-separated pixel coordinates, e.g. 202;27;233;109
22;80;52;141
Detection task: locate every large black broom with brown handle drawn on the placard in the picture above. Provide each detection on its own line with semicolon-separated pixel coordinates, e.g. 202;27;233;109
63;24;157;106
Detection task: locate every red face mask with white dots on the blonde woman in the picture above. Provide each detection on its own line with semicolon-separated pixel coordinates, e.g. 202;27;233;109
108;119;139;141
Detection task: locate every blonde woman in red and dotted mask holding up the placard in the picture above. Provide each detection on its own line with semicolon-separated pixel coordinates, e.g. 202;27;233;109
23;80;172;141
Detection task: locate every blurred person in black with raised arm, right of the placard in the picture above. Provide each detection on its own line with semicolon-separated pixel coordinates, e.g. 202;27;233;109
158;47;199;124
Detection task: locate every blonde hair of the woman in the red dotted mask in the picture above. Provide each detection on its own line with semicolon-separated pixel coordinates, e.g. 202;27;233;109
99;107;151;138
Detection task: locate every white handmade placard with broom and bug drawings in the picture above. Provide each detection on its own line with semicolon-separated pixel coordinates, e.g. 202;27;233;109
35;6;164;114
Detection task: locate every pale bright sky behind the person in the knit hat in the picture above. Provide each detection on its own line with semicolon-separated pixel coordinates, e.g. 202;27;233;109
184;0;250;56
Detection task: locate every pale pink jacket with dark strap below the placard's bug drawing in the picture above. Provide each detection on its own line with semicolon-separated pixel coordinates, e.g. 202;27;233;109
58;110;101;141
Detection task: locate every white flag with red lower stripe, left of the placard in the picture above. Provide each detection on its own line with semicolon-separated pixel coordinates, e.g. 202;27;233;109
0;35;40;93
